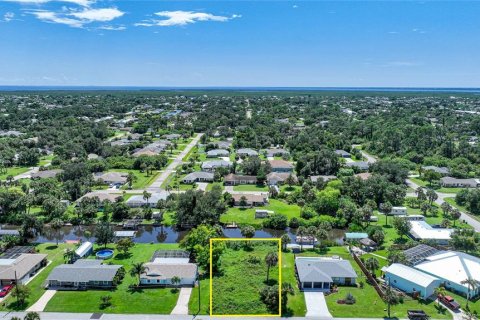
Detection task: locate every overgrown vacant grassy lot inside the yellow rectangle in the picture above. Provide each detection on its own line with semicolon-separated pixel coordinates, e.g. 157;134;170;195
212;241;280;315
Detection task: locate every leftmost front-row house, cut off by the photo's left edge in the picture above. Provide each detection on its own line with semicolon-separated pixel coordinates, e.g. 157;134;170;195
0;253;47;286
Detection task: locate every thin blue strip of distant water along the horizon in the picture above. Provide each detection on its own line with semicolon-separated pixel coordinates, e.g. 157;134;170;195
0;86;480;93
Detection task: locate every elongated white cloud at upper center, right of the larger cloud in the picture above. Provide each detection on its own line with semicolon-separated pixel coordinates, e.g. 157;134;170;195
135;11;241;27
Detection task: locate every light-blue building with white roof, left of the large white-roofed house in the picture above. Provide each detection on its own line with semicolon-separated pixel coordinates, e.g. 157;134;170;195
382;263;441;299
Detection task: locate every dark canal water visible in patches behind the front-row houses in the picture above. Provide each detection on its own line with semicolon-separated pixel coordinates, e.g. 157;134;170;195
4;225;345;244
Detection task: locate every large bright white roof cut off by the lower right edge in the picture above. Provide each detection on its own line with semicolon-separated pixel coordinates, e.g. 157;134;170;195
415;251;480;287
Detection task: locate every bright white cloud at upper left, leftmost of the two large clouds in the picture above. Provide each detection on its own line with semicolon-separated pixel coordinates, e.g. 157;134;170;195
30;8;125;28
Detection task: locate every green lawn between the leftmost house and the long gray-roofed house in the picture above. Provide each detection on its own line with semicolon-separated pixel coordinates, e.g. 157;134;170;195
0;243;74;311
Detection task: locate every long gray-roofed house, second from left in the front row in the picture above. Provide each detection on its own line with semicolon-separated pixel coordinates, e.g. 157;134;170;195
47;259;122;290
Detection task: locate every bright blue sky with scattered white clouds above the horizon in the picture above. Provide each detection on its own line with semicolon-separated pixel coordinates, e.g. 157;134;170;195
0;0;480;88
